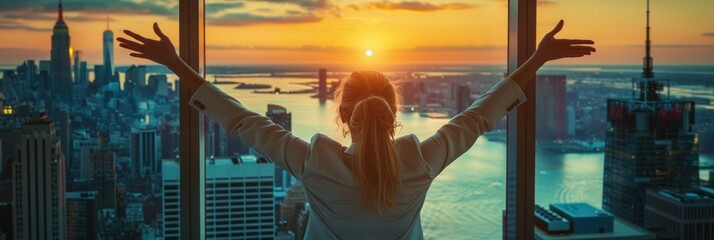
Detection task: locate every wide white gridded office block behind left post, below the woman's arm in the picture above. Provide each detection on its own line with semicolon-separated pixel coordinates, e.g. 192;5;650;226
162;155;276;239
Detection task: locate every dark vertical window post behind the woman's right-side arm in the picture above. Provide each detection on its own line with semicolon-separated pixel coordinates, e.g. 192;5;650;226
503;0;537;240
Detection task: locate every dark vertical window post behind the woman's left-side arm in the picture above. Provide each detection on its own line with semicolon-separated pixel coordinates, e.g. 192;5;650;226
179;0;206;239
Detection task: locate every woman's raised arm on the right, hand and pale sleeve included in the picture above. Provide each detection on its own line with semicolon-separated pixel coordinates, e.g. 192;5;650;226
419;20;595;177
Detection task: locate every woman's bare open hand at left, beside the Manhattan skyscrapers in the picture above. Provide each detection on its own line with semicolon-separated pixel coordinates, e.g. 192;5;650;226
117;23;181;69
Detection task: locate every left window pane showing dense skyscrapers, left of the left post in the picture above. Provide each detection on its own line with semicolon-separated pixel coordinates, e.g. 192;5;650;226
0;0;179;239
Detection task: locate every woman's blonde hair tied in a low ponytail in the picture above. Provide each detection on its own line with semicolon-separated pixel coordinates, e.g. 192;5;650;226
335;71;401;212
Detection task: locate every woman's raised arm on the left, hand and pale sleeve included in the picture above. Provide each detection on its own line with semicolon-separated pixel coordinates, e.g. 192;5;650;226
117;23;309;179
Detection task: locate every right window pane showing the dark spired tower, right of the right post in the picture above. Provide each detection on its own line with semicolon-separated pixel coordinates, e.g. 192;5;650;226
535;0;714;239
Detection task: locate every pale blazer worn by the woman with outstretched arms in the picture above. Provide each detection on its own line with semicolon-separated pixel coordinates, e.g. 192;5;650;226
189;79;526;239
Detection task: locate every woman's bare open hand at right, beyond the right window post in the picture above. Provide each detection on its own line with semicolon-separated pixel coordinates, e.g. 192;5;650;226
534;20;595;63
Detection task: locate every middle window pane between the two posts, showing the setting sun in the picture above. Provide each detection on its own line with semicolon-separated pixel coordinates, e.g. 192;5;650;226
200;0;507;239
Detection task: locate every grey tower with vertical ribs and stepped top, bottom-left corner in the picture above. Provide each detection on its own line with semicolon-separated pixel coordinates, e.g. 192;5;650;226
13;112;66;239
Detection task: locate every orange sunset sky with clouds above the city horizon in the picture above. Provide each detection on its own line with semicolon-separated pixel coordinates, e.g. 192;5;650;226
0;0;714;66
